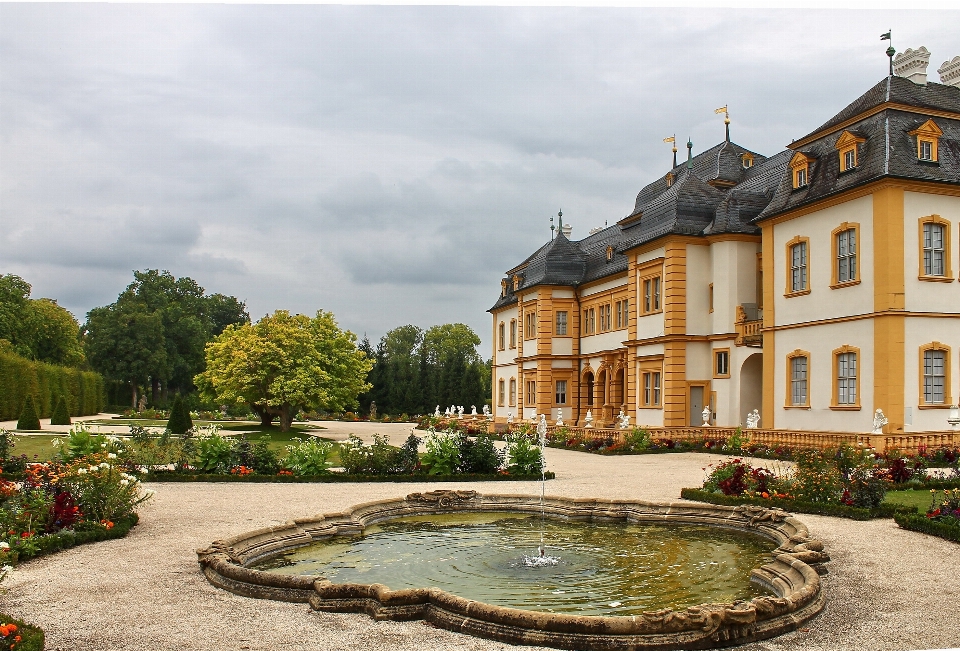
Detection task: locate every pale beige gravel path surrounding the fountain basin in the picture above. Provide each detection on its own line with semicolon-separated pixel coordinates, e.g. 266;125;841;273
0;423;960;651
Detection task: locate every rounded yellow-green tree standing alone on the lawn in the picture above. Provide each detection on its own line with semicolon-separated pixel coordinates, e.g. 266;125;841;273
194;310;373;432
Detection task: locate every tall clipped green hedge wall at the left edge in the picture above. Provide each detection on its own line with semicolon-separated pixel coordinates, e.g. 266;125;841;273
0;353;106;420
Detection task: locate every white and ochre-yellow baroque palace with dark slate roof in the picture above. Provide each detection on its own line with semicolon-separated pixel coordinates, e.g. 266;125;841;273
489;48;960;433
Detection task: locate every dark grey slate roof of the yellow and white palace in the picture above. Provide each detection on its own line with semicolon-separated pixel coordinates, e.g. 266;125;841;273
490;77;960;311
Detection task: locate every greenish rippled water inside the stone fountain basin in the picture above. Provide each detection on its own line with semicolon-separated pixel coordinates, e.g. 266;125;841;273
253;513;776;615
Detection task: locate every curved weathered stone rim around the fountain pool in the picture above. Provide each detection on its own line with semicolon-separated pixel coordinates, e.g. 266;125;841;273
197;490;830;650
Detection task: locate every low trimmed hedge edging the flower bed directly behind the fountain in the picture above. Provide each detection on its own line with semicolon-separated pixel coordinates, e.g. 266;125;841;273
140;471;556;484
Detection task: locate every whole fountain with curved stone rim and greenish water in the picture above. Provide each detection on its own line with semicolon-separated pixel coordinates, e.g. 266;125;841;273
197;492;829;650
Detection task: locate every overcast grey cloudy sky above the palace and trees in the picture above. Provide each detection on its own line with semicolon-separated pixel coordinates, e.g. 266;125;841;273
0;3;960;357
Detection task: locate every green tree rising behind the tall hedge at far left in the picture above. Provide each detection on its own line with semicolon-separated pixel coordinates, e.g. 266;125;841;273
0;274;84;366
